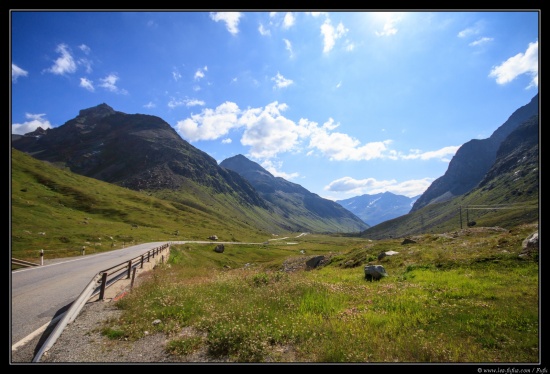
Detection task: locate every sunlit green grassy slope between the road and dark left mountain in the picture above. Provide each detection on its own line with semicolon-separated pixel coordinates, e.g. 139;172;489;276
10;150;280;262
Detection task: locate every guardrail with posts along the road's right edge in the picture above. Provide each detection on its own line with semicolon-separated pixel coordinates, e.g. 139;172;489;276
32;244;170;362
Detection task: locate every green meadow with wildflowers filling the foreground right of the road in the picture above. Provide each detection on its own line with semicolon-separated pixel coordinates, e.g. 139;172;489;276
105;225;540;363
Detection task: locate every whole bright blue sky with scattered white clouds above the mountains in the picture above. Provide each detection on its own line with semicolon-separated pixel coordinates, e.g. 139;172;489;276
10;10;540;200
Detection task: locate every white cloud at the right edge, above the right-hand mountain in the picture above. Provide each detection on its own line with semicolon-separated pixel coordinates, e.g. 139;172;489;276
489;41;539;88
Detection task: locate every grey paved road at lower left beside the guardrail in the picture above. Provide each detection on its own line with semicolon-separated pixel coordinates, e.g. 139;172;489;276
10;242;167;348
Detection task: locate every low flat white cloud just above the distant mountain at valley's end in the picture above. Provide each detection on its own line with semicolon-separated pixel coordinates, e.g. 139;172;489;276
324;177;433;197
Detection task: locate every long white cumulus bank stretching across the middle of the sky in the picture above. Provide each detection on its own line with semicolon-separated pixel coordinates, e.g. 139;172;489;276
176;101;458;162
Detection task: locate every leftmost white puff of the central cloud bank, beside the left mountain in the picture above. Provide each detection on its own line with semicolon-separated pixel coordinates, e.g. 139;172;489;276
175;101;240;142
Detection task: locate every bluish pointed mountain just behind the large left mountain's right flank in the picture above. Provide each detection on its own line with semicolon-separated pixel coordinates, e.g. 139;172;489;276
220;155;369;232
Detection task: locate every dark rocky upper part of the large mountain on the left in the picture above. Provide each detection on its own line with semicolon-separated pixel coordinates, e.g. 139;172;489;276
12;104;266;208
